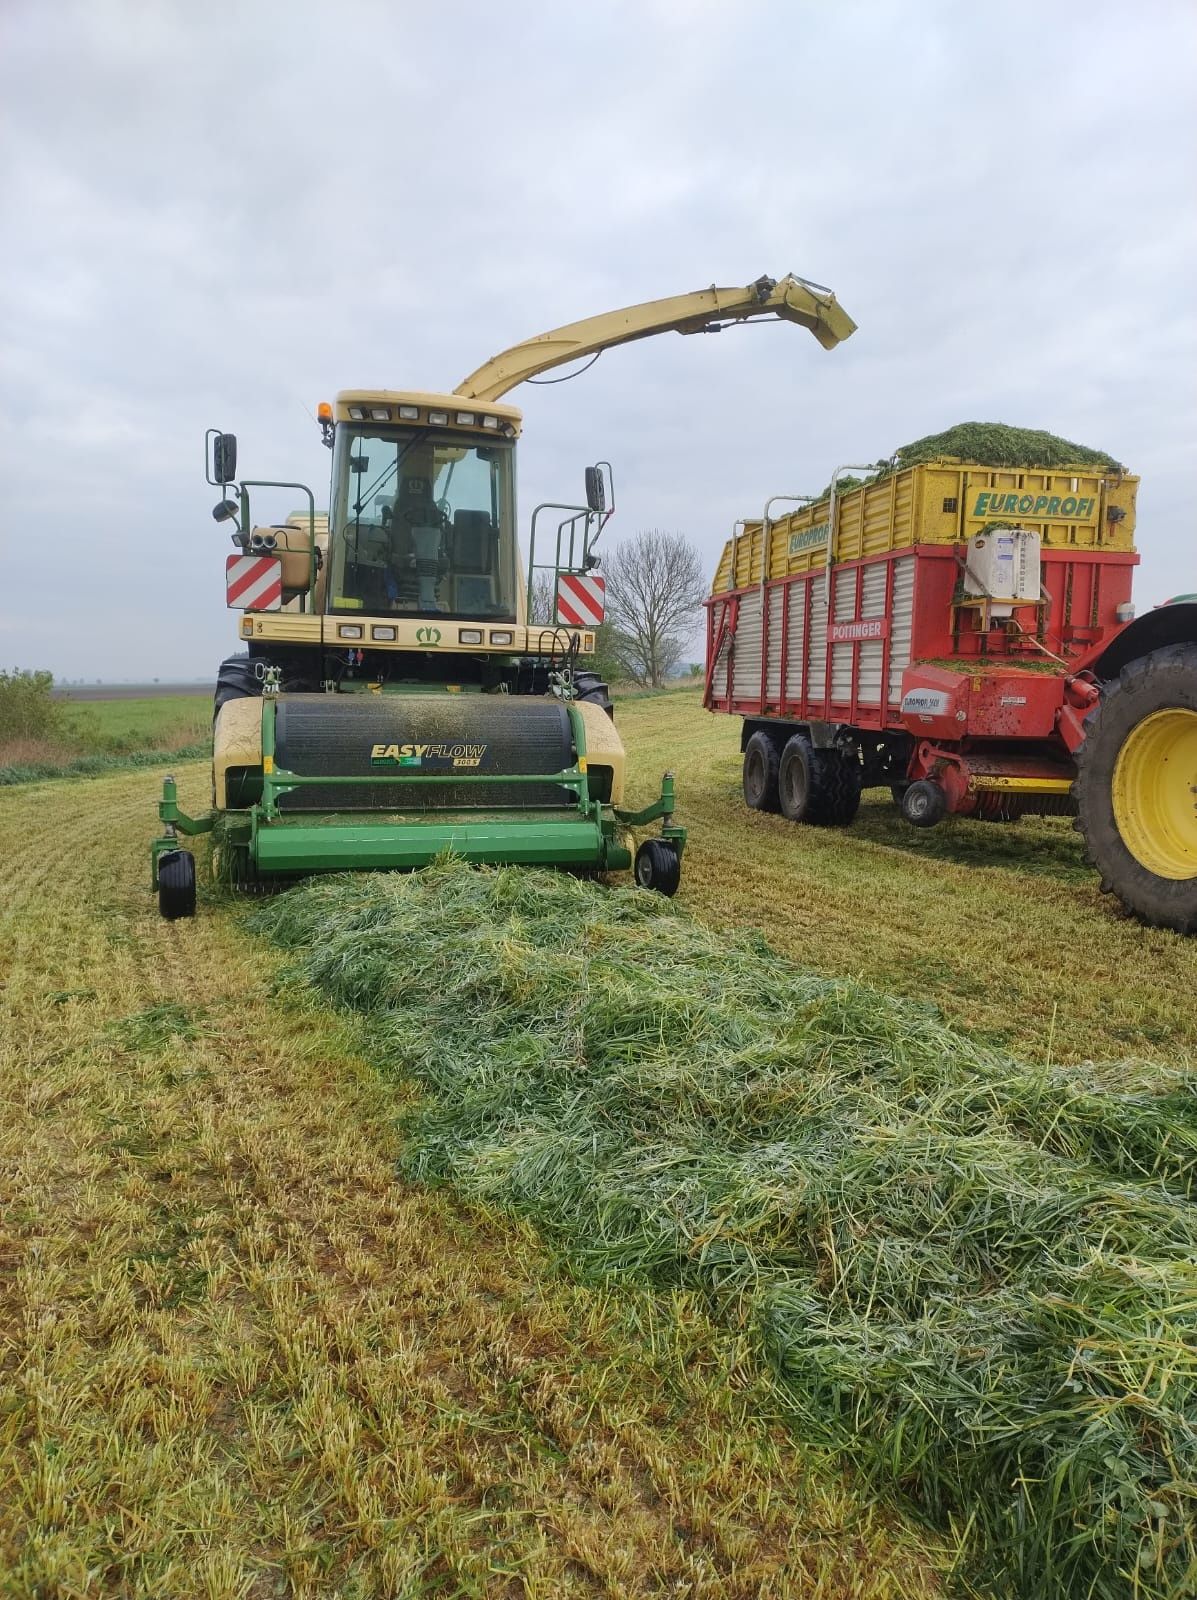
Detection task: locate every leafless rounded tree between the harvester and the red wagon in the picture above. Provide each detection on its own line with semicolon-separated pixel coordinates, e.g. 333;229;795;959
603;528;707;688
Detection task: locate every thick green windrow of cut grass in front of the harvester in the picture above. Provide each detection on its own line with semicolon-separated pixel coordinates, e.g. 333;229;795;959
253;866;1197;1600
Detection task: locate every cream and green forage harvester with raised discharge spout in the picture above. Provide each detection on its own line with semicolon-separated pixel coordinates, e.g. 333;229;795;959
152;277;855;918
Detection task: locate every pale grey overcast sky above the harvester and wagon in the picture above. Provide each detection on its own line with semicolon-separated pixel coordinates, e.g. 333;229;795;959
0;0;1197;680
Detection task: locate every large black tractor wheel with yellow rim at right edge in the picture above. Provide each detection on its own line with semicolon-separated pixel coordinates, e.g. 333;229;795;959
1072;645;1197;933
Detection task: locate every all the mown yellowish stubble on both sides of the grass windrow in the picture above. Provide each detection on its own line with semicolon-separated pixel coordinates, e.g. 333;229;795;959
0;691;1197;1597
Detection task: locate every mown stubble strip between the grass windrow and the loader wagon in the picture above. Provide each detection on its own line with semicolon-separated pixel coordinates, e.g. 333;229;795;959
618;690;1197;1064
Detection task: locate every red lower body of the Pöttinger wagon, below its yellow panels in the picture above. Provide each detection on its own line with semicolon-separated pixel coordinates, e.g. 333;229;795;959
704;518;1138;816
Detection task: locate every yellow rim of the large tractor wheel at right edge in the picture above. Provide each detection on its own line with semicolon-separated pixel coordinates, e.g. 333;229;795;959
1112;706;1197;880
